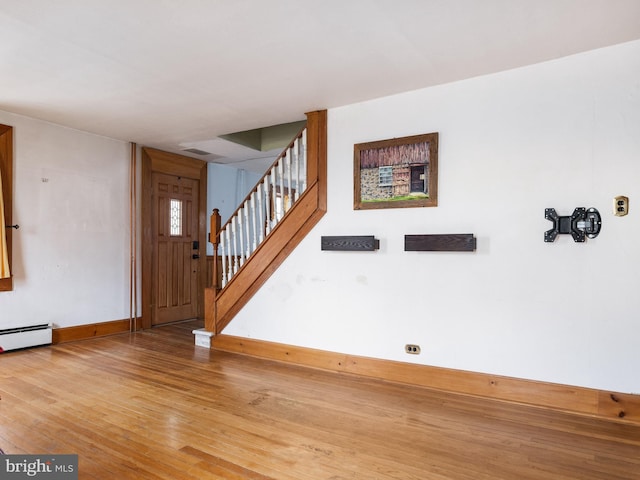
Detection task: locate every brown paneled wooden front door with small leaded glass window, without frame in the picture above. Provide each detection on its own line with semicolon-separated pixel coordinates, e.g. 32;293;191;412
151;172;199;325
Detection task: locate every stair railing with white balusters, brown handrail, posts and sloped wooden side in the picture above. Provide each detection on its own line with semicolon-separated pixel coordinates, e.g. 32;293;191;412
204;110;327;335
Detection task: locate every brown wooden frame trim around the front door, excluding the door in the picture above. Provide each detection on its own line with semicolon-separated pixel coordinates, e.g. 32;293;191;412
140;147;207;329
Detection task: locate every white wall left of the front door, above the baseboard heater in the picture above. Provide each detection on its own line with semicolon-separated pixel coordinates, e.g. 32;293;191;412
0;111;129;329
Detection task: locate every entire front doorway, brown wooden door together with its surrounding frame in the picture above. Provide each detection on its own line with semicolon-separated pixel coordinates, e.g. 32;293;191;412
141;148;207;328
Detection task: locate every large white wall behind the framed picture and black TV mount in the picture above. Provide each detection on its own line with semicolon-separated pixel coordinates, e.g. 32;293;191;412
225;42;640;393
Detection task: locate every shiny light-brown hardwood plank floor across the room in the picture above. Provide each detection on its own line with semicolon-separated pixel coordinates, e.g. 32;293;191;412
0;323;640;480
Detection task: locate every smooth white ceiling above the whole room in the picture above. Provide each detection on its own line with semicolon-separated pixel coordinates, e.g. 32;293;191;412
0;0;640;170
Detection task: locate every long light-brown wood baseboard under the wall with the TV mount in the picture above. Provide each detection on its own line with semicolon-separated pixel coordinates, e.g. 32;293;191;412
212;335;640;423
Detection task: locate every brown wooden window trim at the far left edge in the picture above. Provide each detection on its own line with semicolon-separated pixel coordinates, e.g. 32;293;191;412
0;125;13;292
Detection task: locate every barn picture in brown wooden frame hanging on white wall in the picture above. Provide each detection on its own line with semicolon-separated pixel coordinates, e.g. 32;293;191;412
353;132;438;210
